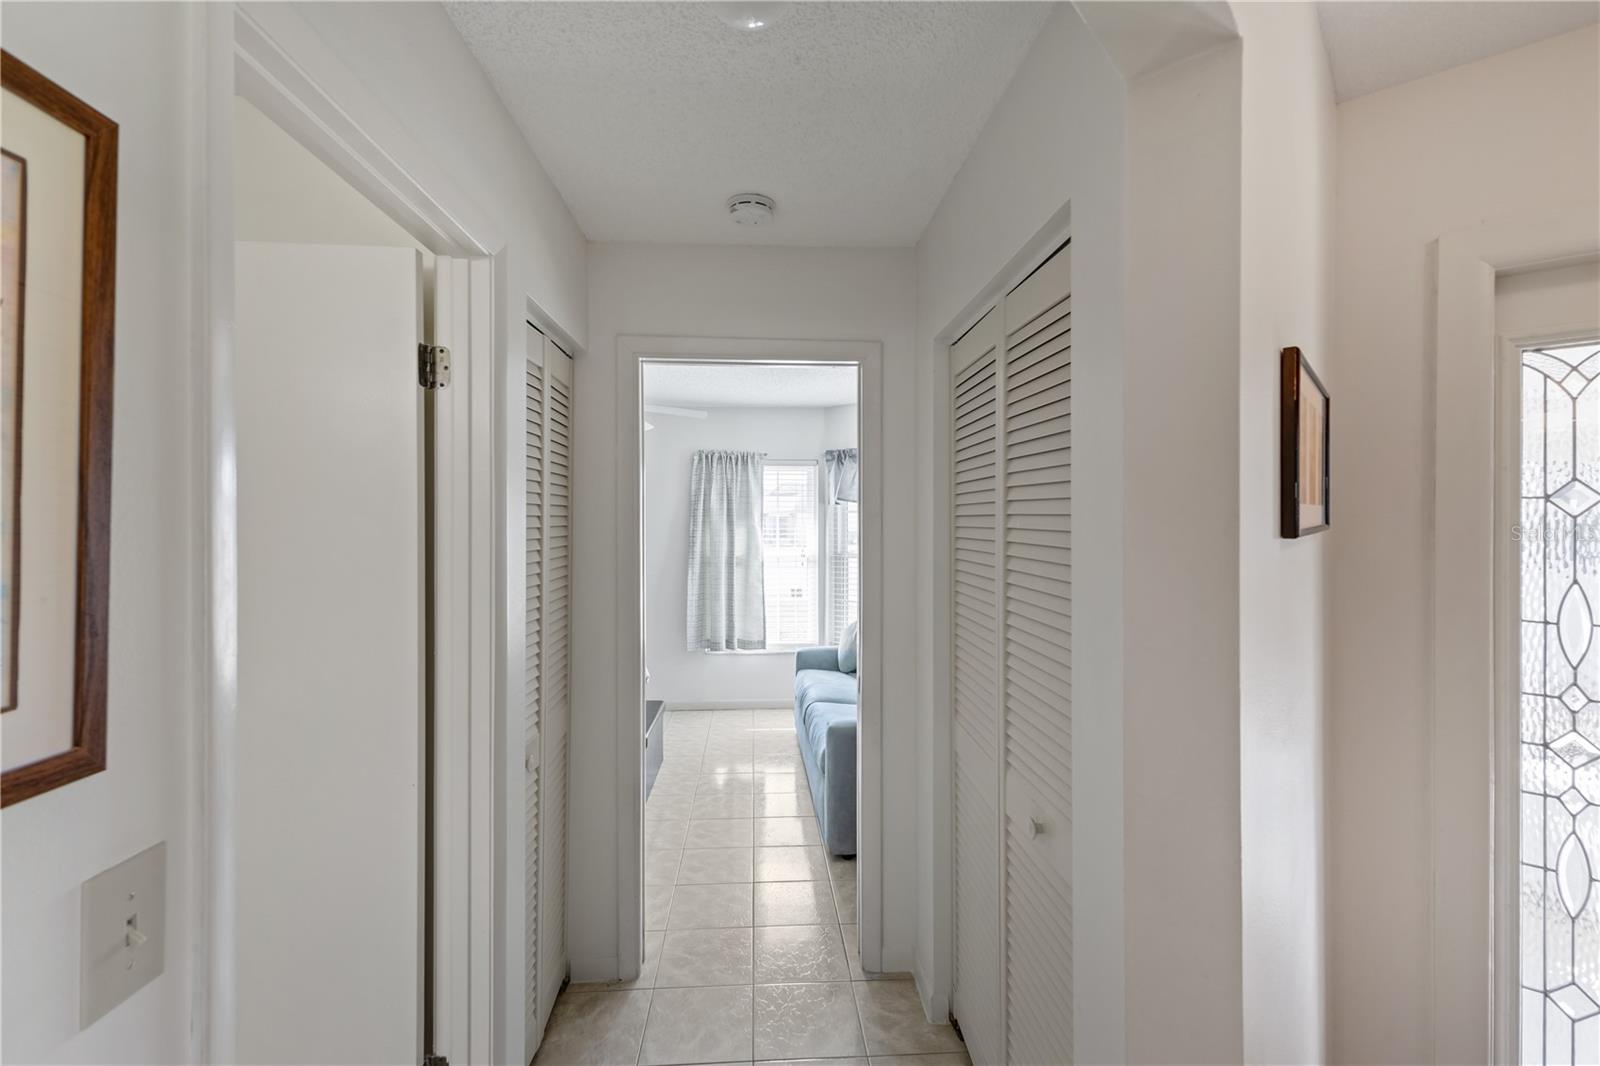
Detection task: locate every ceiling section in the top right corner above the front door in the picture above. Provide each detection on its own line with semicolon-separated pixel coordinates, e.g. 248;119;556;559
1317;0;1600;101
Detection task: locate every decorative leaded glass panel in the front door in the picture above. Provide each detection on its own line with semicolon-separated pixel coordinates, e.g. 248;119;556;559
1518;344;1600;1066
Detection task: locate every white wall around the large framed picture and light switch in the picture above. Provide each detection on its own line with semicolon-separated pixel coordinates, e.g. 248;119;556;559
0;3;202;1063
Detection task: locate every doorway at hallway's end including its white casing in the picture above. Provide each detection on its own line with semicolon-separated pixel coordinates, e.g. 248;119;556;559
604;336;883;1058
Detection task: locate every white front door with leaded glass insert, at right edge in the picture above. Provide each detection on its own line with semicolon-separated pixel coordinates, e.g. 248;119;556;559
1491;252;1600;1063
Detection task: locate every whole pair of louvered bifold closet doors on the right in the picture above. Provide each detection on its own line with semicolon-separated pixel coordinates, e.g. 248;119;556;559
950;248;1072;1064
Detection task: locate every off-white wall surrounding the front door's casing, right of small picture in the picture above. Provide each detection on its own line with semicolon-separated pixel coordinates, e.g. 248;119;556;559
1326;27;1600;1061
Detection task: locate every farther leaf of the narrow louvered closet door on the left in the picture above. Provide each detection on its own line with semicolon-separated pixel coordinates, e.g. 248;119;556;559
539;338;573;1018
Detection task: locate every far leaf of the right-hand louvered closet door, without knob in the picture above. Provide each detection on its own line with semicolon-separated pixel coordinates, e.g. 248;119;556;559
950;311;1000;1063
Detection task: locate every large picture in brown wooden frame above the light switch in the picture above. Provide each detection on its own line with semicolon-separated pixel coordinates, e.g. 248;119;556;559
0;51;117;807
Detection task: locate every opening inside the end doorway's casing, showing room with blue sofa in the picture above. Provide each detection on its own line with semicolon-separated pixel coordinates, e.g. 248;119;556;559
640;360;862;947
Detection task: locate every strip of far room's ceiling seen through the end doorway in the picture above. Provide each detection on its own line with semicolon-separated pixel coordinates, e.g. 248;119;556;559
645;363;856;410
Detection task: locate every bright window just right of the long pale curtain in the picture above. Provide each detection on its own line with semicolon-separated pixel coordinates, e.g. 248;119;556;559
762;461;818;648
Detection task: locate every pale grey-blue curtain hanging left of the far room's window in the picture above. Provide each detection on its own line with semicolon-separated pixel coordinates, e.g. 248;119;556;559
688;451;766;651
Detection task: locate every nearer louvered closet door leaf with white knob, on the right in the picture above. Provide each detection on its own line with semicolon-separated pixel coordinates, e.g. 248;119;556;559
1000;248;1072;1063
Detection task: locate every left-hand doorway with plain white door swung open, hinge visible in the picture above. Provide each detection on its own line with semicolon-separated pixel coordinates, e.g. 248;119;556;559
224;78;490;1061
